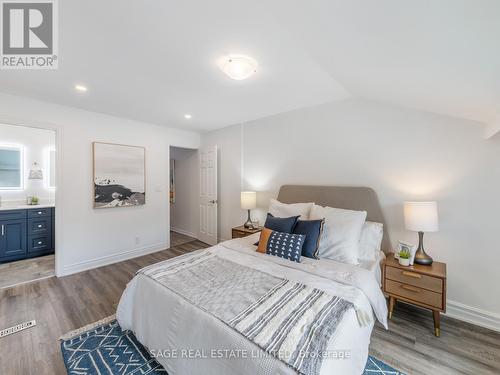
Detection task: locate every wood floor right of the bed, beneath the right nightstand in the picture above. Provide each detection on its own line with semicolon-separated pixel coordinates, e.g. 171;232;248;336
370;302;500;375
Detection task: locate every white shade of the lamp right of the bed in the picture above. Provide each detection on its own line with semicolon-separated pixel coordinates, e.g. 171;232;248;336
404;202;439;232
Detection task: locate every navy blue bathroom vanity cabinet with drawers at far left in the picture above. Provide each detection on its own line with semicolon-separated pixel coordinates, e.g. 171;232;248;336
0;208;54;262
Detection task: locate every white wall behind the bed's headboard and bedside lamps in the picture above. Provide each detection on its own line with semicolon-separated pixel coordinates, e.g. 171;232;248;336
202;100;500;329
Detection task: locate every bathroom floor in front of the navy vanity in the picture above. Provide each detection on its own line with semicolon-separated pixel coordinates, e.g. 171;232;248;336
0;254;55;289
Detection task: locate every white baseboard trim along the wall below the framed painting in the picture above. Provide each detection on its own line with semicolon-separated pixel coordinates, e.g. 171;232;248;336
57;242;168;277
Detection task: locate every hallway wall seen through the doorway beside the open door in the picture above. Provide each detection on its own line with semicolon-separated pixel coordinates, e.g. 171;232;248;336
170;147;200;238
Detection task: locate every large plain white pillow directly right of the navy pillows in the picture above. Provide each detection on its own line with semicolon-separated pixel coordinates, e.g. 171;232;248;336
310;204;366;265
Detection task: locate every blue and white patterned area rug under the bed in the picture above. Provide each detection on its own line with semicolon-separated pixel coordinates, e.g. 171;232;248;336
61;316;404;375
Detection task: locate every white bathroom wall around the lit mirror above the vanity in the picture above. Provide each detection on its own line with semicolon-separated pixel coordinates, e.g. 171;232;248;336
0;124;56;204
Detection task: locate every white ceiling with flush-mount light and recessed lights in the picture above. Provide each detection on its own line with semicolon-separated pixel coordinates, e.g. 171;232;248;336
0;0;500;130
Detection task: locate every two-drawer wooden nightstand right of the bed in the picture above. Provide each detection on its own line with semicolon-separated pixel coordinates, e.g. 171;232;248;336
383;254;446;337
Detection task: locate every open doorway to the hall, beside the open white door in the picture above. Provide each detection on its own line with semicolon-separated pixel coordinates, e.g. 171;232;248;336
170;146;199;247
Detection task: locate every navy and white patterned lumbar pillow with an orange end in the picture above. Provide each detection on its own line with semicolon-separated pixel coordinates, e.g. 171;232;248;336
257;228;306;262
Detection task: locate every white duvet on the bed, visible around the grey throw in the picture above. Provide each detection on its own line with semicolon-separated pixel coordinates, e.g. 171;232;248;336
117;234;387;375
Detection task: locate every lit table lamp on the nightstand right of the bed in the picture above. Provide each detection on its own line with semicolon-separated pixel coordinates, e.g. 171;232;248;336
404;202;439;265
